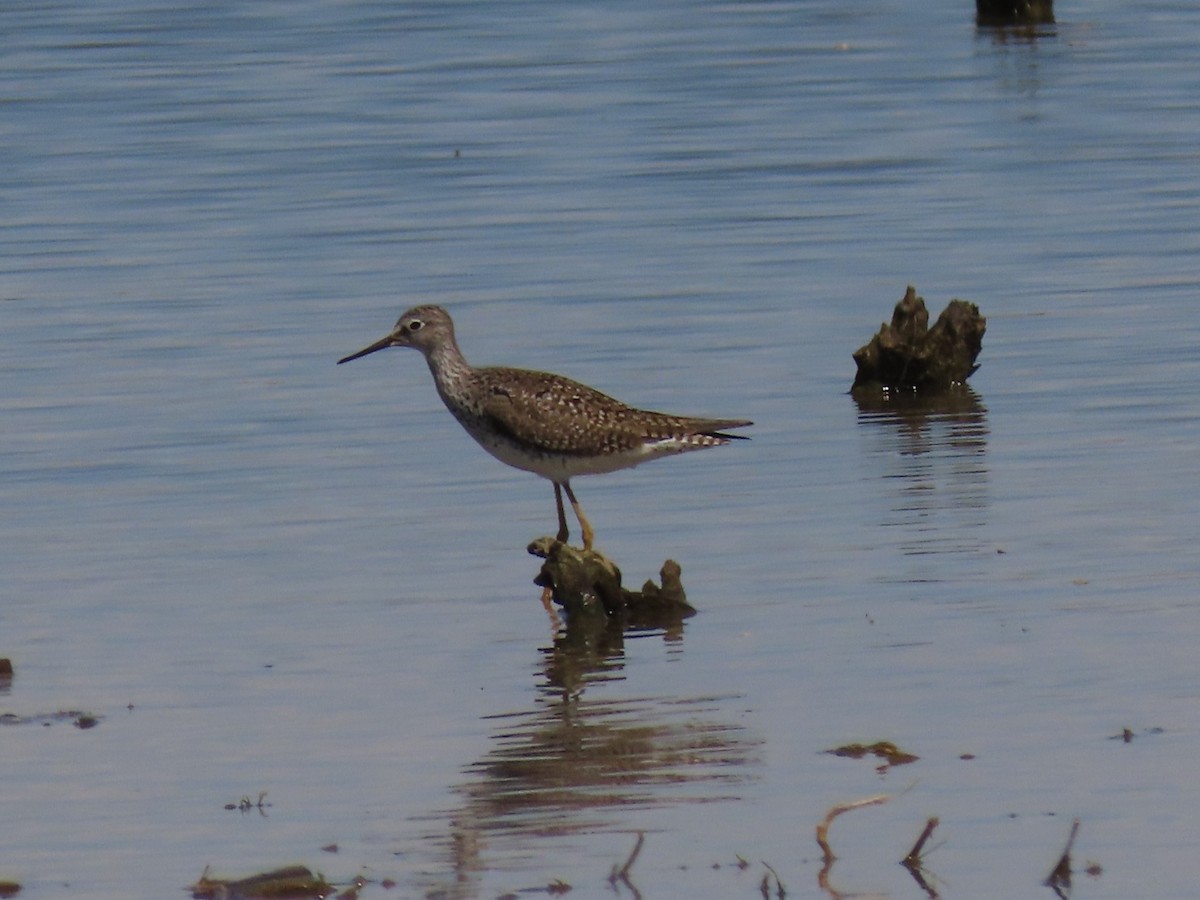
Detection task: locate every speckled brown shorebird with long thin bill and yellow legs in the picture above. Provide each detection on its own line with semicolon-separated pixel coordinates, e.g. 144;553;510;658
338;306;752;550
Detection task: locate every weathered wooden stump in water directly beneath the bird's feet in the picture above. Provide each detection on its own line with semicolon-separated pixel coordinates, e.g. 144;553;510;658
529;538;696;628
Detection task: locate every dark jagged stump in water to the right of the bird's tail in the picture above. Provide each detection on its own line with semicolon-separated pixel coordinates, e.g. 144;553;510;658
851;286;988;394
